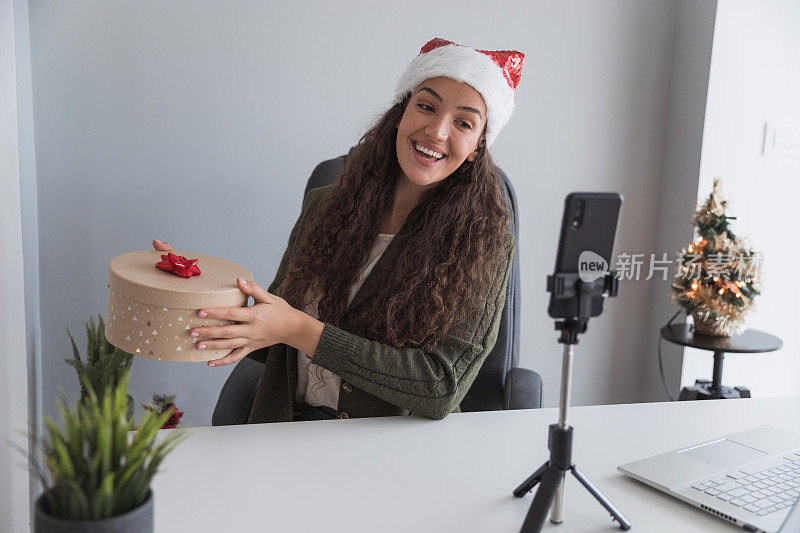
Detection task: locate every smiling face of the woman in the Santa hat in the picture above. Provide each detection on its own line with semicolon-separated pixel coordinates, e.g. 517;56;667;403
397;77;486;188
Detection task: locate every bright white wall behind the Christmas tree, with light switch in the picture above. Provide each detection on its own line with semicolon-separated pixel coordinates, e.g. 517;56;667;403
682;0;800;396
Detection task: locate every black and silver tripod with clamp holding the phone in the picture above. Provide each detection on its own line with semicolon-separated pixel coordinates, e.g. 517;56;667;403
514;271;631;533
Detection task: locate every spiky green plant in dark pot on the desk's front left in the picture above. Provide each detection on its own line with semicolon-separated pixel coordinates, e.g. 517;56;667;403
30;372;184;533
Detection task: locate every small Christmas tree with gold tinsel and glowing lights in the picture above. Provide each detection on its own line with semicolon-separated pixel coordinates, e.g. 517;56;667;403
671;178;761;337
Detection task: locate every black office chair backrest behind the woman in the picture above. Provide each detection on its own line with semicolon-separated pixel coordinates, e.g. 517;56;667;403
304;155;520;412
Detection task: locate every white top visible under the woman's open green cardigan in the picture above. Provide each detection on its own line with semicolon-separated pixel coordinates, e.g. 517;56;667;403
295;233;394;409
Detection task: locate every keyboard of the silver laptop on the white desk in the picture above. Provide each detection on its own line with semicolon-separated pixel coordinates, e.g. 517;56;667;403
692;452;800;516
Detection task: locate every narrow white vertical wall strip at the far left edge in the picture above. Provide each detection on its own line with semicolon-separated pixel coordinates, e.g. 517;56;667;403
0;0;30;531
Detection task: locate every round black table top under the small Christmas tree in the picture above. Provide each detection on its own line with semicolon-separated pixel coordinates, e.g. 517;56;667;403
661;324;783;353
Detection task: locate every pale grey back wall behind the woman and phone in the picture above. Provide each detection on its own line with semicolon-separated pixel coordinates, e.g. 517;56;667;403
20;0;688;425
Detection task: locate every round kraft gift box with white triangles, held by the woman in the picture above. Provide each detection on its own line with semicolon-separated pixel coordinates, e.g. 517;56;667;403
105;250;253;362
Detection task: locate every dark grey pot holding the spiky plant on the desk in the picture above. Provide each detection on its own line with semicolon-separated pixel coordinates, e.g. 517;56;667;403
34;490;153;533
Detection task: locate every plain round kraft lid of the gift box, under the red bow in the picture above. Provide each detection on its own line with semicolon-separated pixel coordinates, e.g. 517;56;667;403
108;250;253;309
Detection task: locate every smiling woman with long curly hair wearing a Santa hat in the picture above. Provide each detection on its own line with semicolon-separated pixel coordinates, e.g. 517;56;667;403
153;39;524;423
